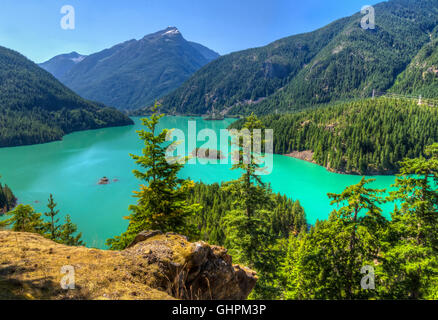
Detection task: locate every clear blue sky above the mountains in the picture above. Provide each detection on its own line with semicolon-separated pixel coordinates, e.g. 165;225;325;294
0;0;381;62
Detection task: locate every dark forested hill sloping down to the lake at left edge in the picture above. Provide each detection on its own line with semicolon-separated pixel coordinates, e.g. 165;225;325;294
0;47;133;147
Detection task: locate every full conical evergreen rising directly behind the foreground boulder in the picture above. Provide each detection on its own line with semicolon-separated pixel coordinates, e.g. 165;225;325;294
107;105;200;250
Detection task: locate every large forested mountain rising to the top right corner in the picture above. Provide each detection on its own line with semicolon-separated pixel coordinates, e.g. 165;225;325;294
155;0;438;114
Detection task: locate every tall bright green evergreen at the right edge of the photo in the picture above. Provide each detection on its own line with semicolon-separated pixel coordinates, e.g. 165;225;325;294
378;144;438;299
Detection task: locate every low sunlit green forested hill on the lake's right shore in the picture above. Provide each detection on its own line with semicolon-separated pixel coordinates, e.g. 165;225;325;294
231;98;438;174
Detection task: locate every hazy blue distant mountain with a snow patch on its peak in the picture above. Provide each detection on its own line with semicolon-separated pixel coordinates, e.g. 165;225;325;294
48;27;219;109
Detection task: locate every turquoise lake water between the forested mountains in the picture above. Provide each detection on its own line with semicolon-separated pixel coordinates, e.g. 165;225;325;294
0;117;394;248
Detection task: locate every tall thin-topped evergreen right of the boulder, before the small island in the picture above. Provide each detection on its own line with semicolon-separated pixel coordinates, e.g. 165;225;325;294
224;114;284;298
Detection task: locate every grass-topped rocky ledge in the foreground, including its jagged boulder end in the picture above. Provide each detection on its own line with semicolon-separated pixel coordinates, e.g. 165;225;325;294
0;231;257;300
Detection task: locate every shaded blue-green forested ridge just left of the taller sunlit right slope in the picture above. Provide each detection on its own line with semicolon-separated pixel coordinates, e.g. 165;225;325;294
156;19;347;114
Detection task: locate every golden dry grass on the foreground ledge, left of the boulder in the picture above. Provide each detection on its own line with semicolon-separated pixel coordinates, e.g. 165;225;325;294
0;231;172;300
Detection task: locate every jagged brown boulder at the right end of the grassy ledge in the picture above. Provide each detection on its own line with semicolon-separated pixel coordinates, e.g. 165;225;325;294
124;231;257;300
